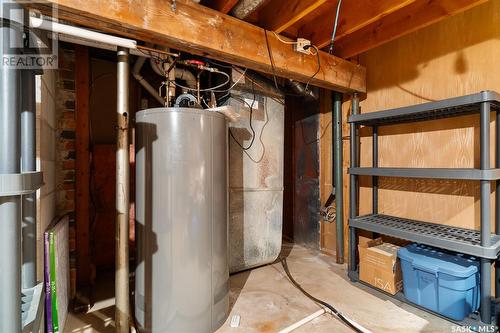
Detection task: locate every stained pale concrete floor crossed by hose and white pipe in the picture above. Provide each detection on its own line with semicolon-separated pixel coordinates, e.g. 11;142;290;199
64;241;454;333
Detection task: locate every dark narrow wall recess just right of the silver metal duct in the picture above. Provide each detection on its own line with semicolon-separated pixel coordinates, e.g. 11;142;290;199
283;96;320;249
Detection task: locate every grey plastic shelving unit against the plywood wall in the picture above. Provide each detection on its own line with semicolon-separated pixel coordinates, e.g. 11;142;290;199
349;91;500;324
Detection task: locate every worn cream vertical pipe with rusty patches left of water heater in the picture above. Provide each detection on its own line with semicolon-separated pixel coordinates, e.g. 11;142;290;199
115;47;130;333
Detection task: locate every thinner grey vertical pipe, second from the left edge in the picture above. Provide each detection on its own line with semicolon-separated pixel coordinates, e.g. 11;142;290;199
21;70;37;288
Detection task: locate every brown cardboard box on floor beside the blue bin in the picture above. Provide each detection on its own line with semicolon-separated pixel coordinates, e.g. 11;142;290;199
358;237;403;295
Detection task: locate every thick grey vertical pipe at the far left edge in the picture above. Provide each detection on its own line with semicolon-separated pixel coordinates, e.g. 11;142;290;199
0;0;22;333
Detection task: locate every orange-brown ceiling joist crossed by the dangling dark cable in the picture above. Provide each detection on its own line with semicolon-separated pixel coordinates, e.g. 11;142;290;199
299;0;416;48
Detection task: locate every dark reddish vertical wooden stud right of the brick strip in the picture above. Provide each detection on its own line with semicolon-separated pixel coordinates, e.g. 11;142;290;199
75;45;92;287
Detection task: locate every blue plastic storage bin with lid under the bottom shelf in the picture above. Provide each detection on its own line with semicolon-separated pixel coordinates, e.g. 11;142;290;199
398;244;480;320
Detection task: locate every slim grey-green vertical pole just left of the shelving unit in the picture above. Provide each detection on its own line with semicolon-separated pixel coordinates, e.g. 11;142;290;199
332;92;344;264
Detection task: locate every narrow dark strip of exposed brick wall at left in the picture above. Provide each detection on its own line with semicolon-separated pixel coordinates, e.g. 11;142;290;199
56;46;76;297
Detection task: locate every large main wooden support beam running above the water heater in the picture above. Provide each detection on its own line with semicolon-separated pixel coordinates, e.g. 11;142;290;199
33;0;366;92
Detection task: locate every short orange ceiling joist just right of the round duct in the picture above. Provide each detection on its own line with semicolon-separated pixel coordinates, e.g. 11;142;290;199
259;0;327;33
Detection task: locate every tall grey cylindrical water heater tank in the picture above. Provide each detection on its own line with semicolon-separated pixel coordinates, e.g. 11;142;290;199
135;108;229;333
